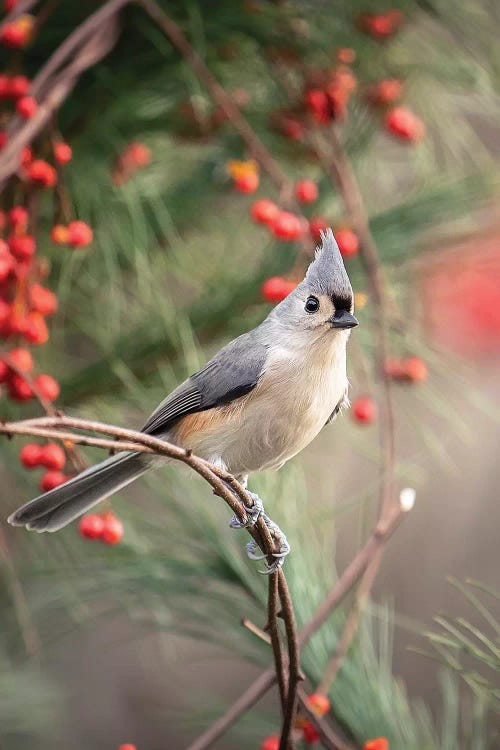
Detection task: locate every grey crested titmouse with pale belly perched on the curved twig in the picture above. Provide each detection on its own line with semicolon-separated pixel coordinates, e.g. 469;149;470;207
8;229;358;572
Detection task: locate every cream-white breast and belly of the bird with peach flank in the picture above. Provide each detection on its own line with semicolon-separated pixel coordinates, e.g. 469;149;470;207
177;345;347;475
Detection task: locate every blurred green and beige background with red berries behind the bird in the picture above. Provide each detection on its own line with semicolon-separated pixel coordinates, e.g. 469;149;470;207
0;0;500;750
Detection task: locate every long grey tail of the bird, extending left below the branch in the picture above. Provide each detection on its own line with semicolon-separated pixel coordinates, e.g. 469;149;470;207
8;453;151;531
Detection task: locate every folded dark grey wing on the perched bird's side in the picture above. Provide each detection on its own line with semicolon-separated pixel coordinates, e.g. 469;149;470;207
142;330;267;435
